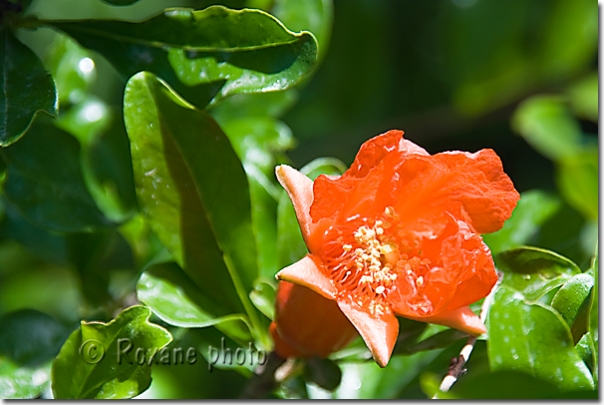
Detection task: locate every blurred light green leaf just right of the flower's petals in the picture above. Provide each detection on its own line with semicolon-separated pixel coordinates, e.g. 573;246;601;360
483;190;561;253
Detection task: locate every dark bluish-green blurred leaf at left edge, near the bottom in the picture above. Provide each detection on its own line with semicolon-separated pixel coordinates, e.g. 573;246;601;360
0;309;70;368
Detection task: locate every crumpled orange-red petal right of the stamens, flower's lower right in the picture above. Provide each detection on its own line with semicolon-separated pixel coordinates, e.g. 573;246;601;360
388;213;497;317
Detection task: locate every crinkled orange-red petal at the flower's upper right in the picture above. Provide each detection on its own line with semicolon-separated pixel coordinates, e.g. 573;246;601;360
391;149;520;234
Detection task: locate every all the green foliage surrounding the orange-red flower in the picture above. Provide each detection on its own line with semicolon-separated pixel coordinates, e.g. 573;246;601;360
0;0;599;399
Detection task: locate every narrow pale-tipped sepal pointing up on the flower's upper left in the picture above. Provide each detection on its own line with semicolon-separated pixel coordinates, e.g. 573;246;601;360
275;165;313;245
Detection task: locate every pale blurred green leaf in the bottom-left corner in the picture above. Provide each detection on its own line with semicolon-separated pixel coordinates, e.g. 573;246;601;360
0;355;50;399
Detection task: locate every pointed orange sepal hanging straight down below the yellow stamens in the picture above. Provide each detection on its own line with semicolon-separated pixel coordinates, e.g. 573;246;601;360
337;298;398;367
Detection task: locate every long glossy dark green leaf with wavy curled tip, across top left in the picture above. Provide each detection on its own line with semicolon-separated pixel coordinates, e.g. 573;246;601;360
49;6;317;107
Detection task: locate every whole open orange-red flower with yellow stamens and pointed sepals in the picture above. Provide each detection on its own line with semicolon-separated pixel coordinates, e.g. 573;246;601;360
271;130;519;367
